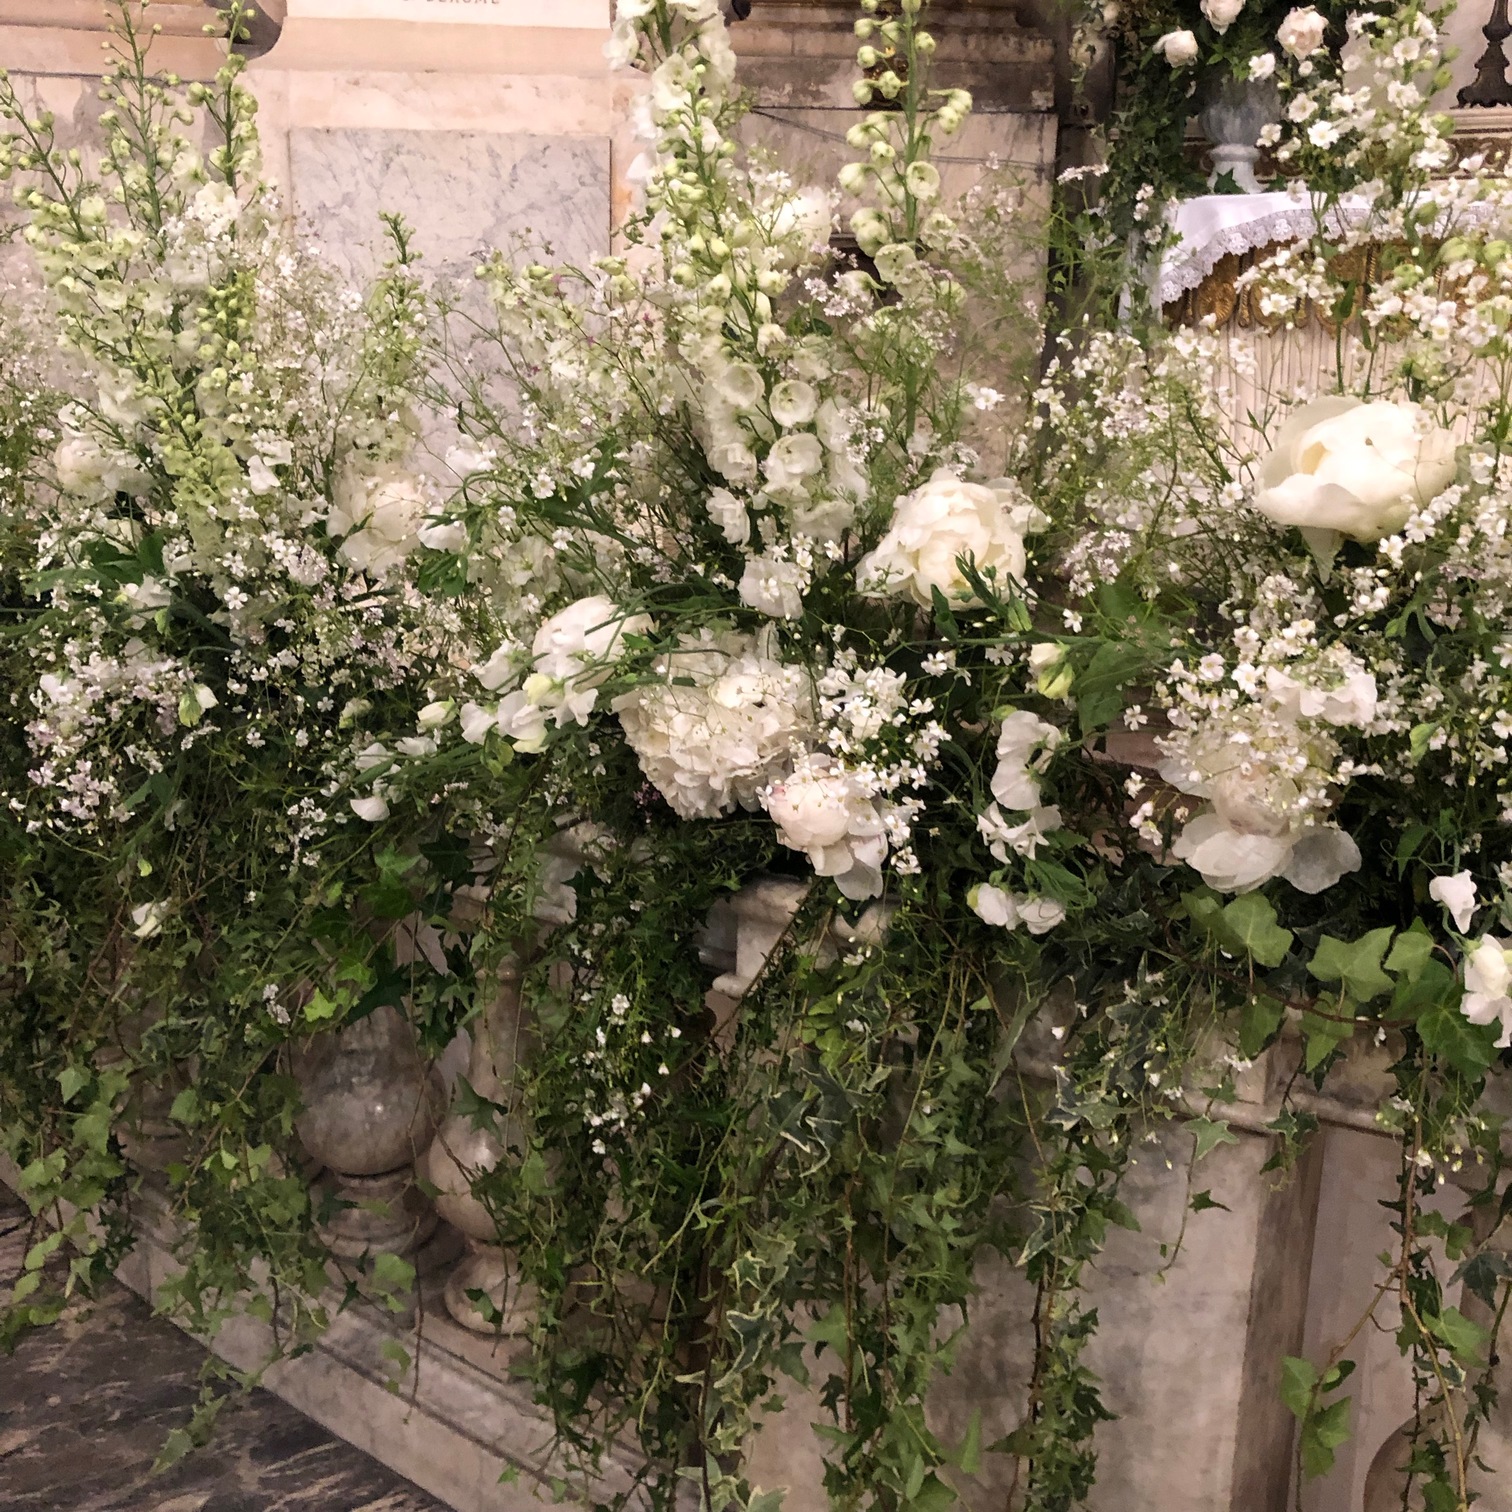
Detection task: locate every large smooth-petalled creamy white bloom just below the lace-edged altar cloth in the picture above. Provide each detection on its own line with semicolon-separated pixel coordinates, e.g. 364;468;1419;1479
1255;395;1455;549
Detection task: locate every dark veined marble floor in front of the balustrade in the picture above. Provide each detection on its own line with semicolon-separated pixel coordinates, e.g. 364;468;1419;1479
0;1187;446;1512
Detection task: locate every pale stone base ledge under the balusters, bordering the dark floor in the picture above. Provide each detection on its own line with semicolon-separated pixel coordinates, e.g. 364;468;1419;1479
0;1155;635;1512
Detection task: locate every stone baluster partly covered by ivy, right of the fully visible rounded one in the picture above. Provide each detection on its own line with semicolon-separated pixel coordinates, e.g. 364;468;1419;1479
423;959;537;1335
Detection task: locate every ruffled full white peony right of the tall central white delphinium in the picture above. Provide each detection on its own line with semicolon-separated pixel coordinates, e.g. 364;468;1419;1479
856;467;1045;608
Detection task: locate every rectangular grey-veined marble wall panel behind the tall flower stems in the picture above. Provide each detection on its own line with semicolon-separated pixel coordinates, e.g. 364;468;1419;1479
289;127;609;280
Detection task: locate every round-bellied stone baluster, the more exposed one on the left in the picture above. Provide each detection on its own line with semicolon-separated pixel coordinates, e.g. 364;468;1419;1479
293;1005;446;1259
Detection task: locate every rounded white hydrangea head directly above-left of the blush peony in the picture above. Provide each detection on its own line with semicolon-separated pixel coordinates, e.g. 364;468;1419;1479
614;631;813;820
